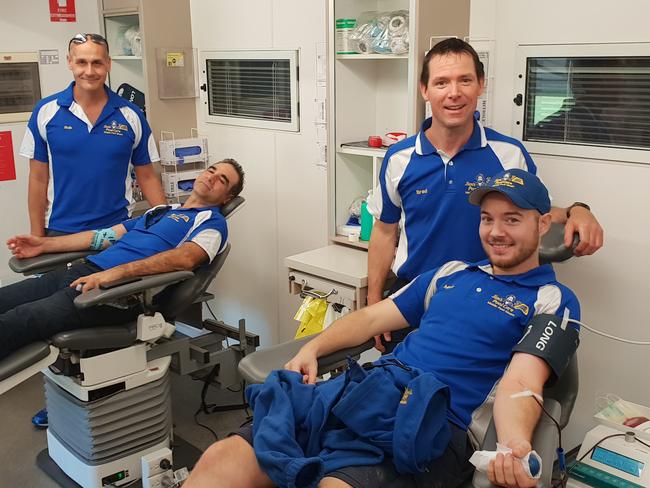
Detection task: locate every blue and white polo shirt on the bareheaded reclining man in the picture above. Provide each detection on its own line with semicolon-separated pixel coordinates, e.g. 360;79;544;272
88;204;228;269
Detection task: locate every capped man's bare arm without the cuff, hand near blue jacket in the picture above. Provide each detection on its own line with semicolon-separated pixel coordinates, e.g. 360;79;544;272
285;298;408;384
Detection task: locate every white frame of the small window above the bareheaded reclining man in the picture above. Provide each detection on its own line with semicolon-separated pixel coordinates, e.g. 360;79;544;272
200;49;300;132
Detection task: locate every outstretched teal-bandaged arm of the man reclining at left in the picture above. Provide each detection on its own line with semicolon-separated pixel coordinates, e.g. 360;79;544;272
7;224;126;259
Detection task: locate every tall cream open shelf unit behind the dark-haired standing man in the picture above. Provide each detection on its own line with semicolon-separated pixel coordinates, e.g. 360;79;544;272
327;0;469;244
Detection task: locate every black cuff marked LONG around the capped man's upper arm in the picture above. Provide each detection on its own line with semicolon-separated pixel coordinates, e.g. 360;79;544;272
512;314;580;384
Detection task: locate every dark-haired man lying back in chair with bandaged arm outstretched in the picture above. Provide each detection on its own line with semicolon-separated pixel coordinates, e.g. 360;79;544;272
0;159;244;359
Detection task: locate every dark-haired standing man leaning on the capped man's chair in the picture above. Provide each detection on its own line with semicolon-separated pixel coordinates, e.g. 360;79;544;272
368;38;603;351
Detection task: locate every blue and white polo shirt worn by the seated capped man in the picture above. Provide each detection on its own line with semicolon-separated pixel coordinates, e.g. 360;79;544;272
391;261;580;429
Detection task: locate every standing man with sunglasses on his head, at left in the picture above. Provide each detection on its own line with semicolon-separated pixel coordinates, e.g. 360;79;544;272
20;34;165;236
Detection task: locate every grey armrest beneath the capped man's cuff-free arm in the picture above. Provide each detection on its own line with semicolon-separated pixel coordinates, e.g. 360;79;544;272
238;335;374;383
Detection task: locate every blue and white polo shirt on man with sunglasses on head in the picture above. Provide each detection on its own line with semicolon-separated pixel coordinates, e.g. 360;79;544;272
20;82;160;233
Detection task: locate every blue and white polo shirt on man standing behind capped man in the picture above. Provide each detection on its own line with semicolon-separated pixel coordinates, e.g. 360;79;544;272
368;118;537;280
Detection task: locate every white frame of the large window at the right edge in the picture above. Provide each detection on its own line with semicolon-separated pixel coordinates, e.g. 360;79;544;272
512;42;650;164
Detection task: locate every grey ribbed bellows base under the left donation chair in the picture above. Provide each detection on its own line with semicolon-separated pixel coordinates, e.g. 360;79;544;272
44;346;172;488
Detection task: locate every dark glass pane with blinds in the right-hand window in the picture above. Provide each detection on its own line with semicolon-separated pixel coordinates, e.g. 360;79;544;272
523;56;650;149
